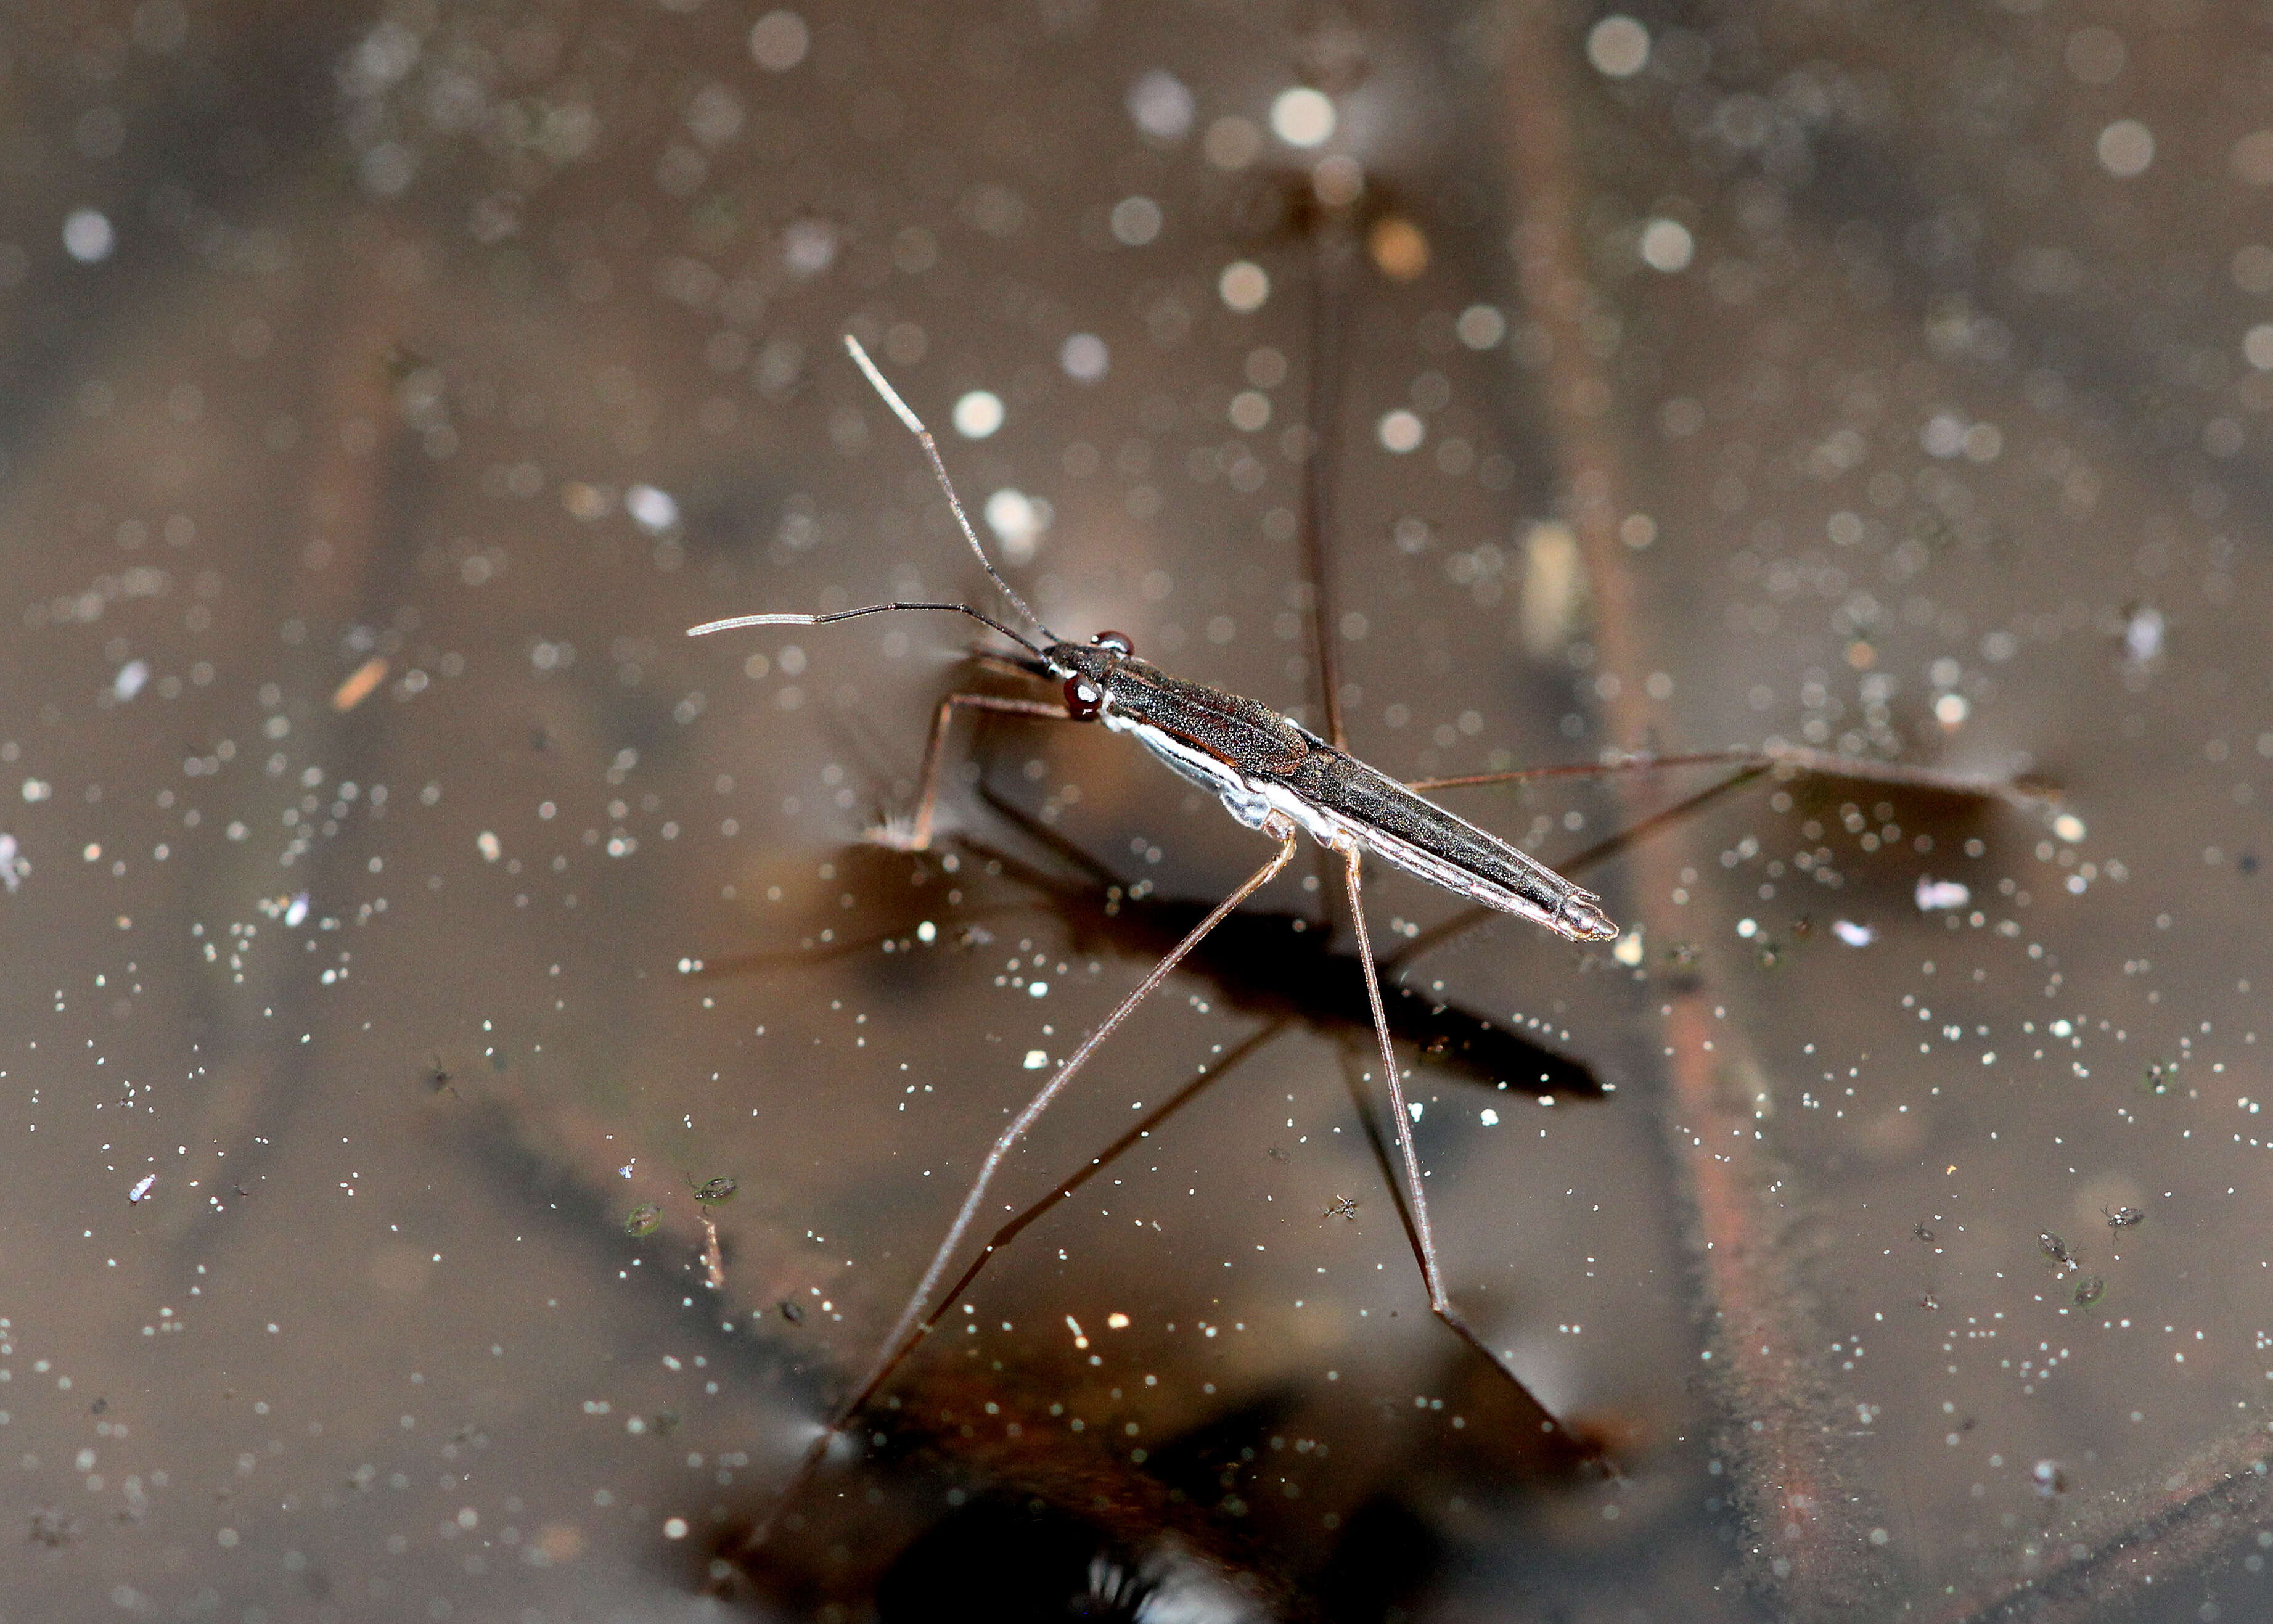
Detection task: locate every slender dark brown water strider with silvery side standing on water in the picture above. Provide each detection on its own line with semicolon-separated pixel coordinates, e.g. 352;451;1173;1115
689;334;2036;1547
